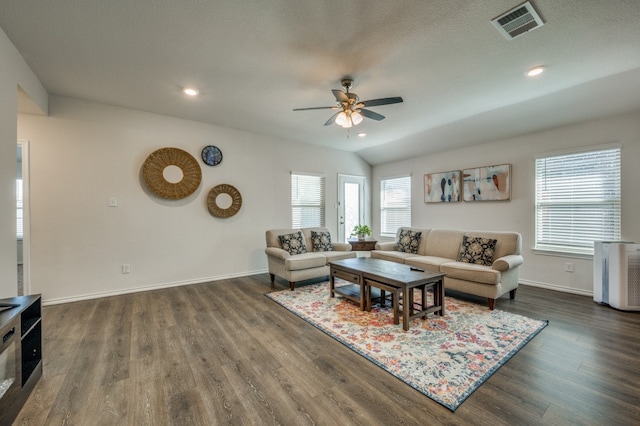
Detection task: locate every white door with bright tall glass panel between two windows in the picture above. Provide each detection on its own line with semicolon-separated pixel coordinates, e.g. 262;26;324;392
338;175;365;242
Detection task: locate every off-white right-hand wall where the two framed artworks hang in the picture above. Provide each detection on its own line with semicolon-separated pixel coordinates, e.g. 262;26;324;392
372;113;640;294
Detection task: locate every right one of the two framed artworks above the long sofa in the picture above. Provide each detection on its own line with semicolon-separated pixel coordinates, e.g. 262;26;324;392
462;164;511;201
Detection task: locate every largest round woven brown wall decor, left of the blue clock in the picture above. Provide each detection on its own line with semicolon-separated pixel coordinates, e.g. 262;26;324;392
142;148;202;200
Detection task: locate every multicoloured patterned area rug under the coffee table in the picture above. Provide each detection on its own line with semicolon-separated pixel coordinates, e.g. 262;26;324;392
266;280;548;411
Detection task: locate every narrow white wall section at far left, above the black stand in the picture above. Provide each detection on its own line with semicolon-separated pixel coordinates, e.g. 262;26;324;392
0;29;47;298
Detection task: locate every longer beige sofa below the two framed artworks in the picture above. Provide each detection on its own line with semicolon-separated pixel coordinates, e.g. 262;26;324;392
371;228;524;310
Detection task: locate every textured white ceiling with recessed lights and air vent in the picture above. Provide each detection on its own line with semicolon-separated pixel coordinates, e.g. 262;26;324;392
0;0;640;164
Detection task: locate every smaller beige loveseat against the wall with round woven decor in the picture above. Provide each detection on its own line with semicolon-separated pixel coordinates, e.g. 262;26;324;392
265;228;356;290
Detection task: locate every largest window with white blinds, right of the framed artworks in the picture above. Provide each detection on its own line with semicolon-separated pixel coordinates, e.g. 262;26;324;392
535;147;620;255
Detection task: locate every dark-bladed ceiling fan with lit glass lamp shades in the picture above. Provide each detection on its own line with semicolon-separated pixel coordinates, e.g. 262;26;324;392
294;78;403;129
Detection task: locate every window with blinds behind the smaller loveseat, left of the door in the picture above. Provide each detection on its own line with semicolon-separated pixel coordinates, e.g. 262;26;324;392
291;173;325;228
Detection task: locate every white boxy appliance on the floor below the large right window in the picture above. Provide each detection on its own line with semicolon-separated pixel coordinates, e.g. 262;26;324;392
593;241;640;311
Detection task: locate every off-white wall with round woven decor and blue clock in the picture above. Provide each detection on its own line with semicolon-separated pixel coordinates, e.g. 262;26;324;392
17;96;370;303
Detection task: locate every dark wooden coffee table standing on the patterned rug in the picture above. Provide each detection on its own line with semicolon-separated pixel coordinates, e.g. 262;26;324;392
329;257;445;330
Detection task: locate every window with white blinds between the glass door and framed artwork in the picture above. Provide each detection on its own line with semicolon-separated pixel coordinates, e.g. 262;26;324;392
380;176;411;237
